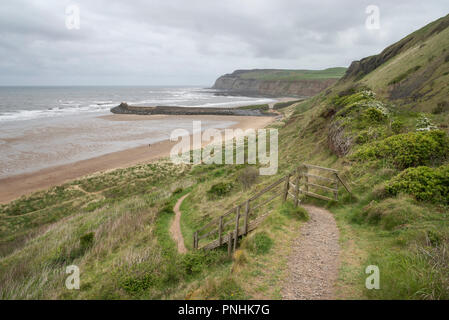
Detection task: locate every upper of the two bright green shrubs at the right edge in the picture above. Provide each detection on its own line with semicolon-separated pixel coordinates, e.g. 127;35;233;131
352;130;449;169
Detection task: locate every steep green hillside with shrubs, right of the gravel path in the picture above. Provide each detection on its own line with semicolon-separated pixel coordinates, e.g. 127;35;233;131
272;16;449;299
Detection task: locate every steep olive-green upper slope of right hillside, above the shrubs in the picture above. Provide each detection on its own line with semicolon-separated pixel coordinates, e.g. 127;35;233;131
341;16;449;113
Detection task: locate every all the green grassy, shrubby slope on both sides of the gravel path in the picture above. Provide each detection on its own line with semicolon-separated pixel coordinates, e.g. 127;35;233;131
0;16;449;299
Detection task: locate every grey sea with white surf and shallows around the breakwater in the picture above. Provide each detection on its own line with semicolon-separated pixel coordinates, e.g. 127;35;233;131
0;86;274;179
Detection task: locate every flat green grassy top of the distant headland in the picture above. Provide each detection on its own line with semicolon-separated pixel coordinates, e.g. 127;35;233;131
233;67;346;81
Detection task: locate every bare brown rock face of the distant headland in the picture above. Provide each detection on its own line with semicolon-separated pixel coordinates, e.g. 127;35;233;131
212;70;338;97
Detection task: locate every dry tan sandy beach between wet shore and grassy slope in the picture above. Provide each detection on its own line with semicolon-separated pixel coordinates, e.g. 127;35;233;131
0;115;275;203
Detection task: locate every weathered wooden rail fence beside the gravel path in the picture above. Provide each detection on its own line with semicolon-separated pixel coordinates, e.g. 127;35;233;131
193;164;351;255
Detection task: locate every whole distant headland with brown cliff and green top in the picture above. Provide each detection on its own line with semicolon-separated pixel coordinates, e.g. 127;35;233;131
212;68;346;97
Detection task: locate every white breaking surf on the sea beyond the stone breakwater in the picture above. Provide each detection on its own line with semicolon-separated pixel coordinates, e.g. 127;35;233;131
0;87;274;122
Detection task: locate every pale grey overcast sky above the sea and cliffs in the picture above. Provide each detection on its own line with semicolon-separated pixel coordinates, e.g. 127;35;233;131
0;0;449;85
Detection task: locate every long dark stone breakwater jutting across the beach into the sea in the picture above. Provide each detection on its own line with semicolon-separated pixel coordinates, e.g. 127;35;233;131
111;102;277;117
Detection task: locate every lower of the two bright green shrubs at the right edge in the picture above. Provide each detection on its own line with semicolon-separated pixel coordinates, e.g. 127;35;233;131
386;165;449;203
